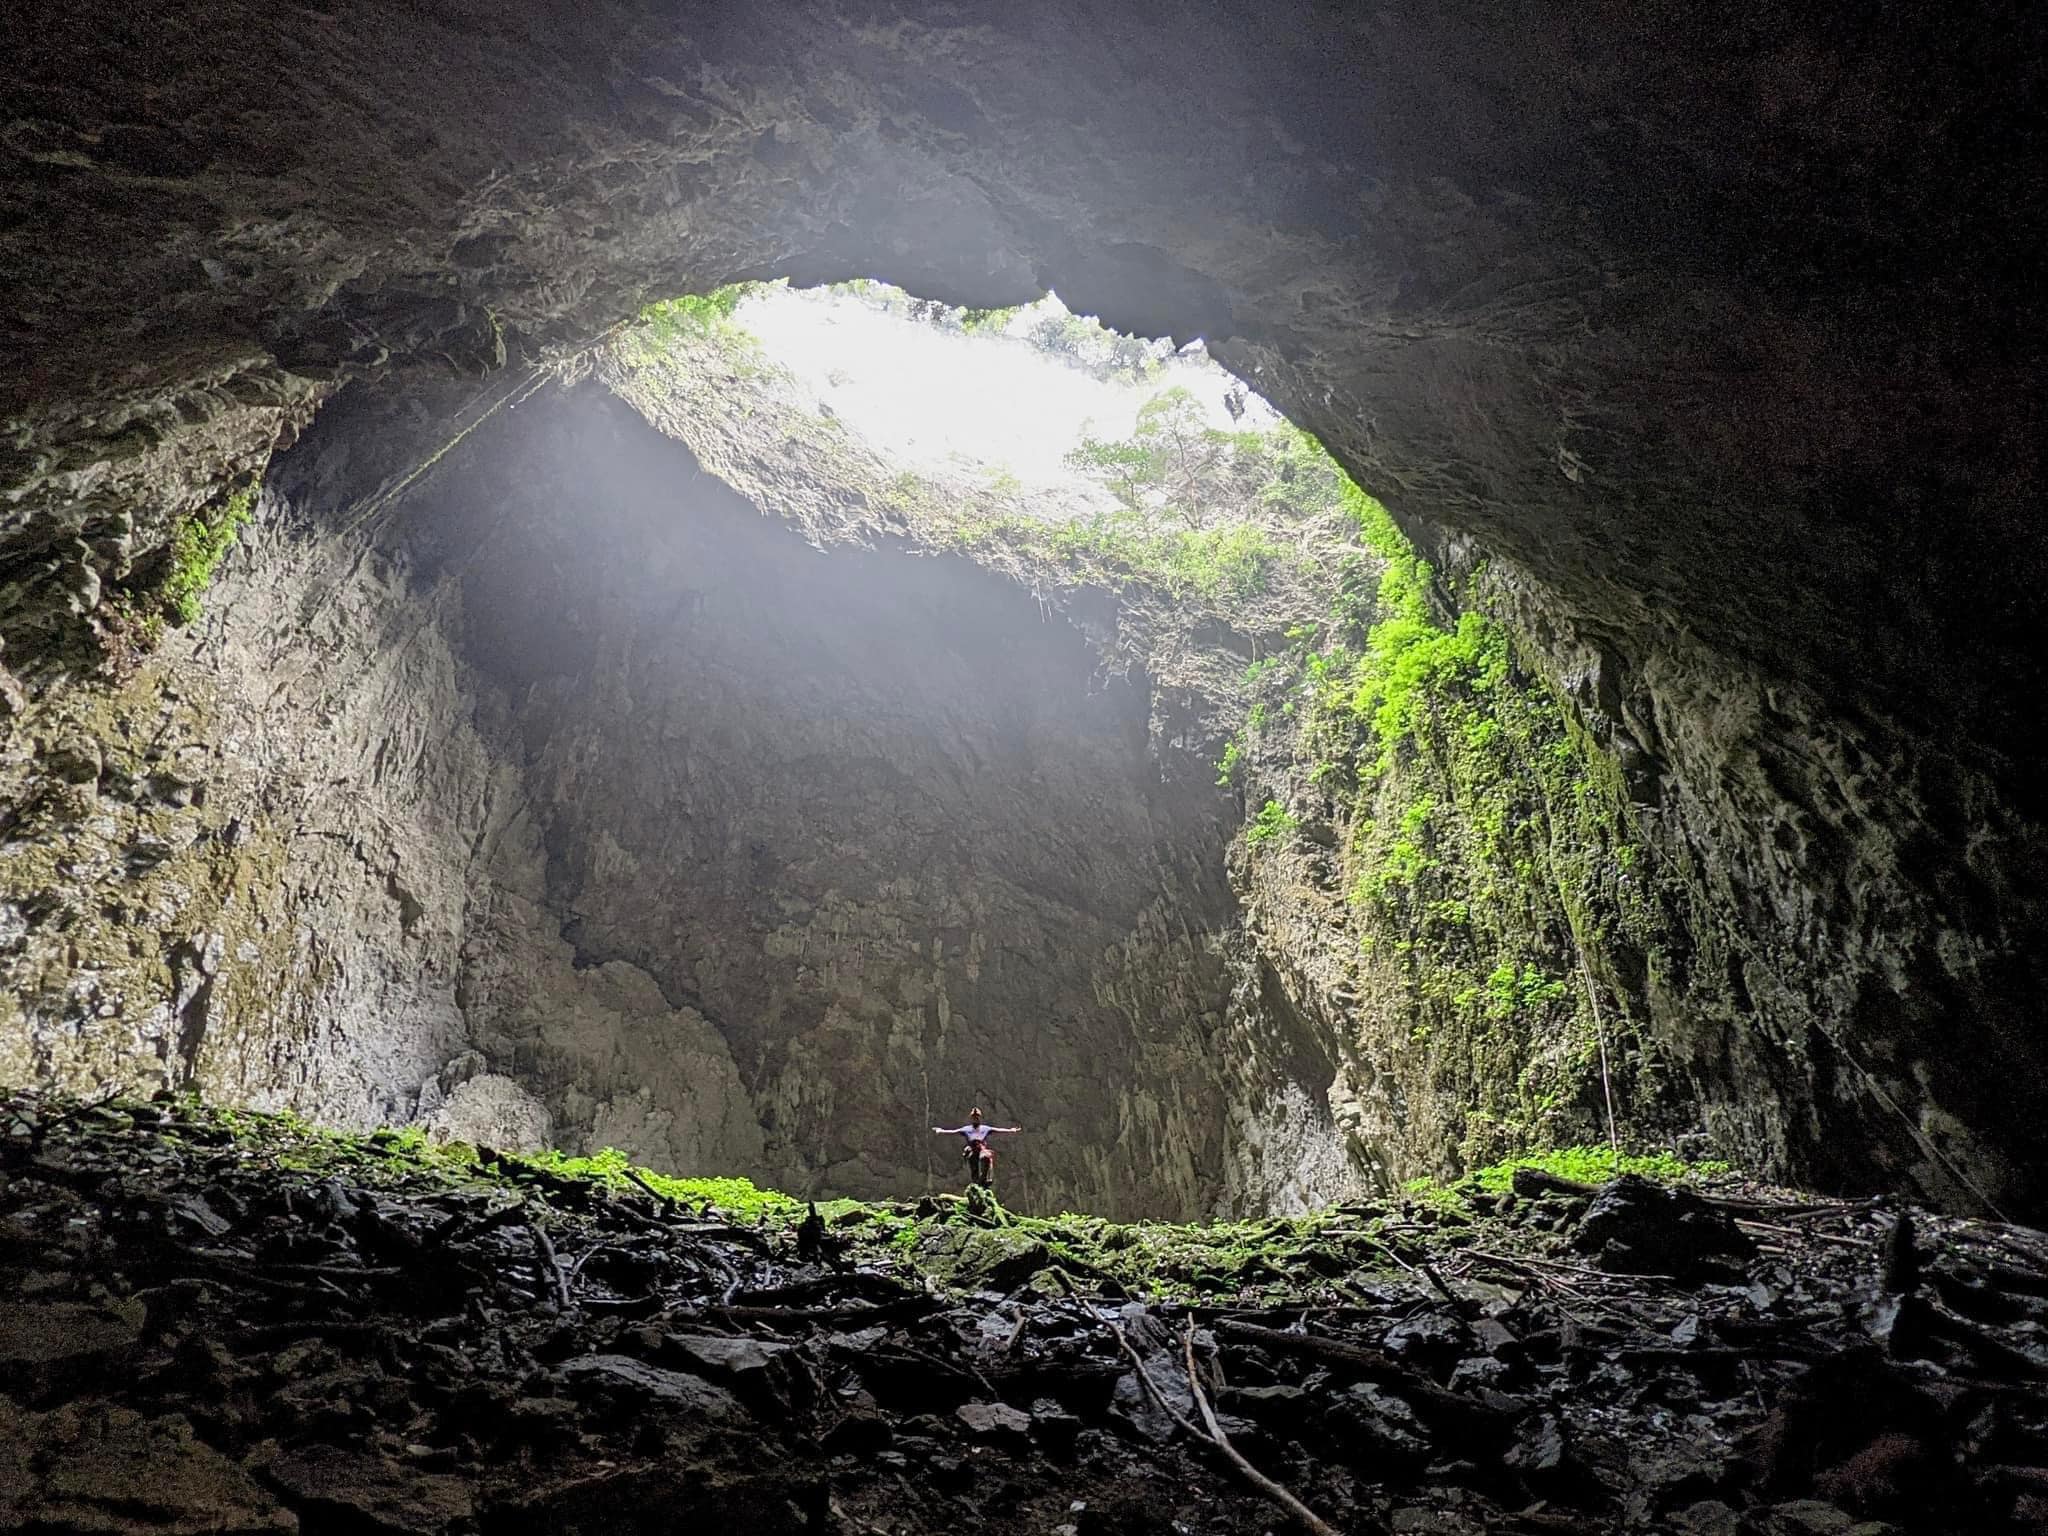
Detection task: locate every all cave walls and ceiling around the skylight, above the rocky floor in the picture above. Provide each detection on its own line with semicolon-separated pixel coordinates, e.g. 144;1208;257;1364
0;0;2048;1530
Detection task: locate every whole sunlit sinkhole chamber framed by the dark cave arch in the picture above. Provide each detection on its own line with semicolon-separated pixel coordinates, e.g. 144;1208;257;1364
12;270;1690;1219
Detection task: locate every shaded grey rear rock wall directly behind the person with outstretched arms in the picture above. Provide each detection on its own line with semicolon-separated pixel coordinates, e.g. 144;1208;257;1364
422;378;1327;1210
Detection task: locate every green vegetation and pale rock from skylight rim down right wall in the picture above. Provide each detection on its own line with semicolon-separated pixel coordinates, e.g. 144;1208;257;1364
610;270;1692;1167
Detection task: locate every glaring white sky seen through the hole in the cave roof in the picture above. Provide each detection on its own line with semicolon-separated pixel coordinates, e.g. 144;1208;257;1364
733;287;1278;502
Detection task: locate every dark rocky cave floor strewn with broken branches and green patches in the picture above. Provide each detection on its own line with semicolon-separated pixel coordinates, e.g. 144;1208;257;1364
0;1094;2048;1536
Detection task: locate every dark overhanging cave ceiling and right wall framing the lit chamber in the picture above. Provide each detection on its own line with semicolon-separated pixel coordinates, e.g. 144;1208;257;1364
0;6;2042;1210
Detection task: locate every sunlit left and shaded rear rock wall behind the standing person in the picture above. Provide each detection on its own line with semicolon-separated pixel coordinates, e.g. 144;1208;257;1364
12;387;1352;1214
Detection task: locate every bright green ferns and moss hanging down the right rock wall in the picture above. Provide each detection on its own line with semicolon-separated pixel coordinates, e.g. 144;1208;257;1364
1233;468;1675;1165
